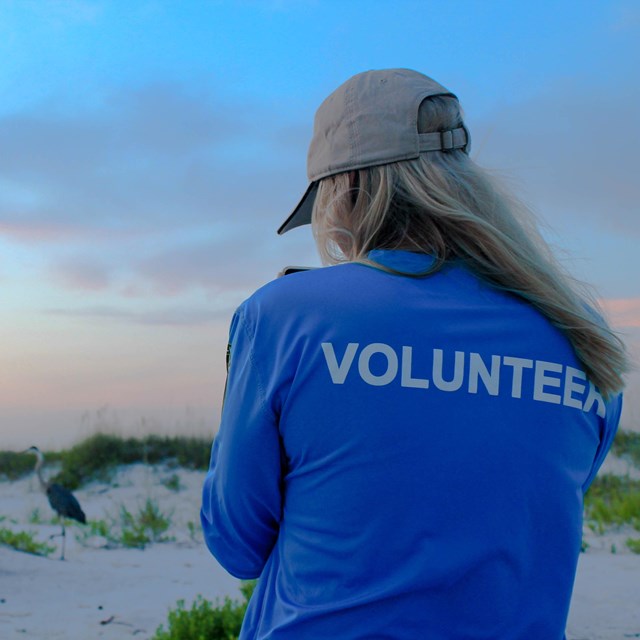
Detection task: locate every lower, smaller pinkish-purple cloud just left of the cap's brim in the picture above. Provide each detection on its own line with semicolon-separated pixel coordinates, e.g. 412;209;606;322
43;214;312;299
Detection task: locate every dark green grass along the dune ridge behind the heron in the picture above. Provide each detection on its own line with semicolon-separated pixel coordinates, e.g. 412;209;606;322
0;433;212;490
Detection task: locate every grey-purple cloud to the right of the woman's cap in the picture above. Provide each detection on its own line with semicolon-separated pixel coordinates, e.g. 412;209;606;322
472;78;640;235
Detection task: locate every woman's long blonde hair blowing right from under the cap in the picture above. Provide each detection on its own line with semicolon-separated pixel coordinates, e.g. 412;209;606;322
312;96;628;398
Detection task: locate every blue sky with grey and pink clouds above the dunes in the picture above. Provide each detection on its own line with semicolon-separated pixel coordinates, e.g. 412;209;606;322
0;0;640;448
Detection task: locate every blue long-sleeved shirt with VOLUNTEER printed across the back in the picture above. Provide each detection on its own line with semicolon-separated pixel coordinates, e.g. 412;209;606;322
201;251;621;640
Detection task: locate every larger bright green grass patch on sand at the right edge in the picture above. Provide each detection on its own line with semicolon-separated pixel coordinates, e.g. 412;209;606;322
585;474;640;533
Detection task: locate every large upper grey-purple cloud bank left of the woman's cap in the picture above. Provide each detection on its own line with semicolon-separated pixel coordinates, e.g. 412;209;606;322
0;83;304;242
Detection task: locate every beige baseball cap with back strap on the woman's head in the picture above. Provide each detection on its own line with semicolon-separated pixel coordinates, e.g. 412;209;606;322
278;69;471;234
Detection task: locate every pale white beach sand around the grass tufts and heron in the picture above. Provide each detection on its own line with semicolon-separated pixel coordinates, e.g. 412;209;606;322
0;460;640;640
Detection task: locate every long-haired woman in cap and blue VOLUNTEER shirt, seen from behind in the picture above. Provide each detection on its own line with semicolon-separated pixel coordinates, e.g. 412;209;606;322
202;69;626;640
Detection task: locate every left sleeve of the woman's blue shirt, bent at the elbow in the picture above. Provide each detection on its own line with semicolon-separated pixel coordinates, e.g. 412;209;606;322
200;306;282;579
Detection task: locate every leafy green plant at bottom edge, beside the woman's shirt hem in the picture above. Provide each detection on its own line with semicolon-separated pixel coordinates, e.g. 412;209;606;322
152;581;255;640
